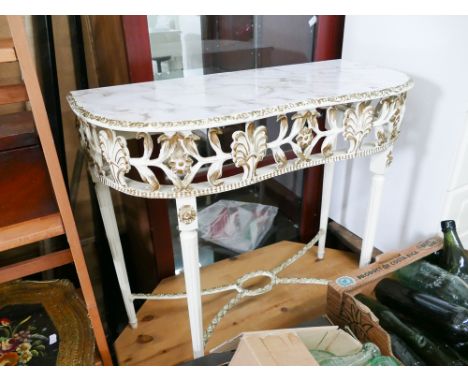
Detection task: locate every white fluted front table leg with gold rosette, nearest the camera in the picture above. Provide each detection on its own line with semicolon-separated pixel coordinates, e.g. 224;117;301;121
176;197;204;358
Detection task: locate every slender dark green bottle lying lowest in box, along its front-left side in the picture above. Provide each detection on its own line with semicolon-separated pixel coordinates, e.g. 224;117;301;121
356;294;465;366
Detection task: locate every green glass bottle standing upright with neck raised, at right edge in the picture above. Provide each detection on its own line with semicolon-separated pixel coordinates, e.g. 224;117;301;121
440;220;468;281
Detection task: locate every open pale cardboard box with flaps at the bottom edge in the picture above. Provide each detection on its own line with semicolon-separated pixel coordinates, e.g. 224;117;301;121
211;326;362;366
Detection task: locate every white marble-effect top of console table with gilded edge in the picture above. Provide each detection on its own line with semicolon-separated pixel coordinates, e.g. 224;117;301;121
69;60;412;133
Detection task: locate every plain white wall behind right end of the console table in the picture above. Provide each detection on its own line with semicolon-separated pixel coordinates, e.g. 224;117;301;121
331;16;468;250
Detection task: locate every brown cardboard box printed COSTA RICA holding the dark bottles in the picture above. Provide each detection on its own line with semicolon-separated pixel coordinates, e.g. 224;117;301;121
327;236;443;355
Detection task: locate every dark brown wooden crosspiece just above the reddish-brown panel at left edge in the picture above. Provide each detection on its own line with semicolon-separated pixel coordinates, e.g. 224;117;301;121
0;111;39;151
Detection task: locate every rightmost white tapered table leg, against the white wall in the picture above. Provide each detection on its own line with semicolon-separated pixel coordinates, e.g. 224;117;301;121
359;147;392;267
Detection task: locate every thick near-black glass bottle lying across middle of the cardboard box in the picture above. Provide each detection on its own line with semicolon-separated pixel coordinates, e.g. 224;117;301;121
375;279;468;343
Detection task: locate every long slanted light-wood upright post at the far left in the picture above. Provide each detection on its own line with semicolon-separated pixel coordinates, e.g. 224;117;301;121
7;16;112;365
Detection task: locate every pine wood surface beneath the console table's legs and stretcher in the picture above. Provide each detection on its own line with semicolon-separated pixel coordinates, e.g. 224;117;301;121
114;241;357;365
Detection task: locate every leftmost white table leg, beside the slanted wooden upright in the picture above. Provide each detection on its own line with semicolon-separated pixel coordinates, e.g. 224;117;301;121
94;182;138;328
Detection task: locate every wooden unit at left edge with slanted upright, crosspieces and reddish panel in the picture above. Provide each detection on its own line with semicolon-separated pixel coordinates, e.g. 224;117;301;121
0;16;112;365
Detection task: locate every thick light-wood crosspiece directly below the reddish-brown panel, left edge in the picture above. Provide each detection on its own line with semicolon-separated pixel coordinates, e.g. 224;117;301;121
0;212;65;252
